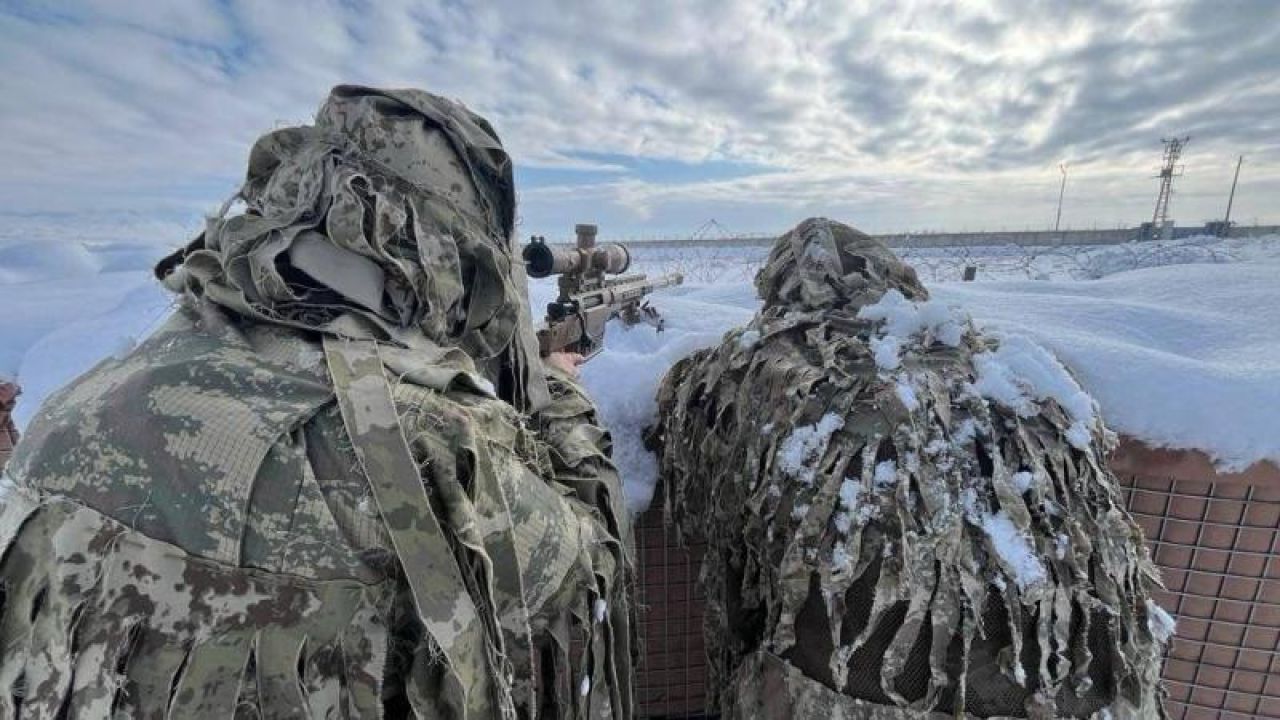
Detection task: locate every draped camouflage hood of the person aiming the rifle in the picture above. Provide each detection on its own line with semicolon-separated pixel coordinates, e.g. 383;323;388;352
156;86;547;410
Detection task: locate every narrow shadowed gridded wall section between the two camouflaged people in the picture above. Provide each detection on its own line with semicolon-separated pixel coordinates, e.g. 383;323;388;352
636;503;707;717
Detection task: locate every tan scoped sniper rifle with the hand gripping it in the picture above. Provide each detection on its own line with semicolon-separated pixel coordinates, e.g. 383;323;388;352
524;225;685;359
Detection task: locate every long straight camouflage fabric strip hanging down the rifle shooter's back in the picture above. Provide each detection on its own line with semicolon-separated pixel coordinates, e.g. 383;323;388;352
324;337;515;717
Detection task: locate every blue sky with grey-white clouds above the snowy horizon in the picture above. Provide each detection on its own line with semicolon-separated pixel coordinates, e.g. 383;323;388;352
0;0;1280;243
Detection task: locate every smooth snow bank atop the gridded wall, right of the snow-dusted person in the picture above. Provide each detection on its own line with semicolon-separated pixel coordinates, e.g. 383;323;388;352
933;259;1280;471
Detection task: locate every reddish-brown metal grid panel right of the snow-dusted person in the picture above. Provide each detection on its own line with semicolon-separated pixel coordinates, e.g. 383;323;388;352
1121;475;1280;720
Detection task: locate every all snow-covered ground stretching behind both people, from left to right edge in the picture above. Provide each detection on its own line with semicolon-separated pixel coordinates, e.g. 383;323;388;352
0;236;1280;509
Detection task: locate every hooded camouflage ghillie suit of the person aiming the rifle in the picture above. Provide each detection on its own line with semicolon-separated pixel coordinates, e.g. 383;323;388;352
0;86;632;719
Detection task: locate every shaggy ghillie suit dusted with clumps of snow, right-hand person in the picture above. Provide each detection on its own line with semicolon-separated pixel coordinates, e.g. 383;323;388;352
658;219;1169;720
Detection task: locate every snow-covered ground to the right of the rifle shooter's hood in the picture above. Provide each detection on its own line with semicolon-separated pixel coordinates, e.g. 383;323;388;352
547;236;1280;509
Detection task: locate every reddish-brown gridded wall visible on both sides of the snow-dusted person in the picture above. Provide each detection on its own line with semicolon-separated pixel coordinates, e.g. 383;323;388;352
636;441;1280;720
